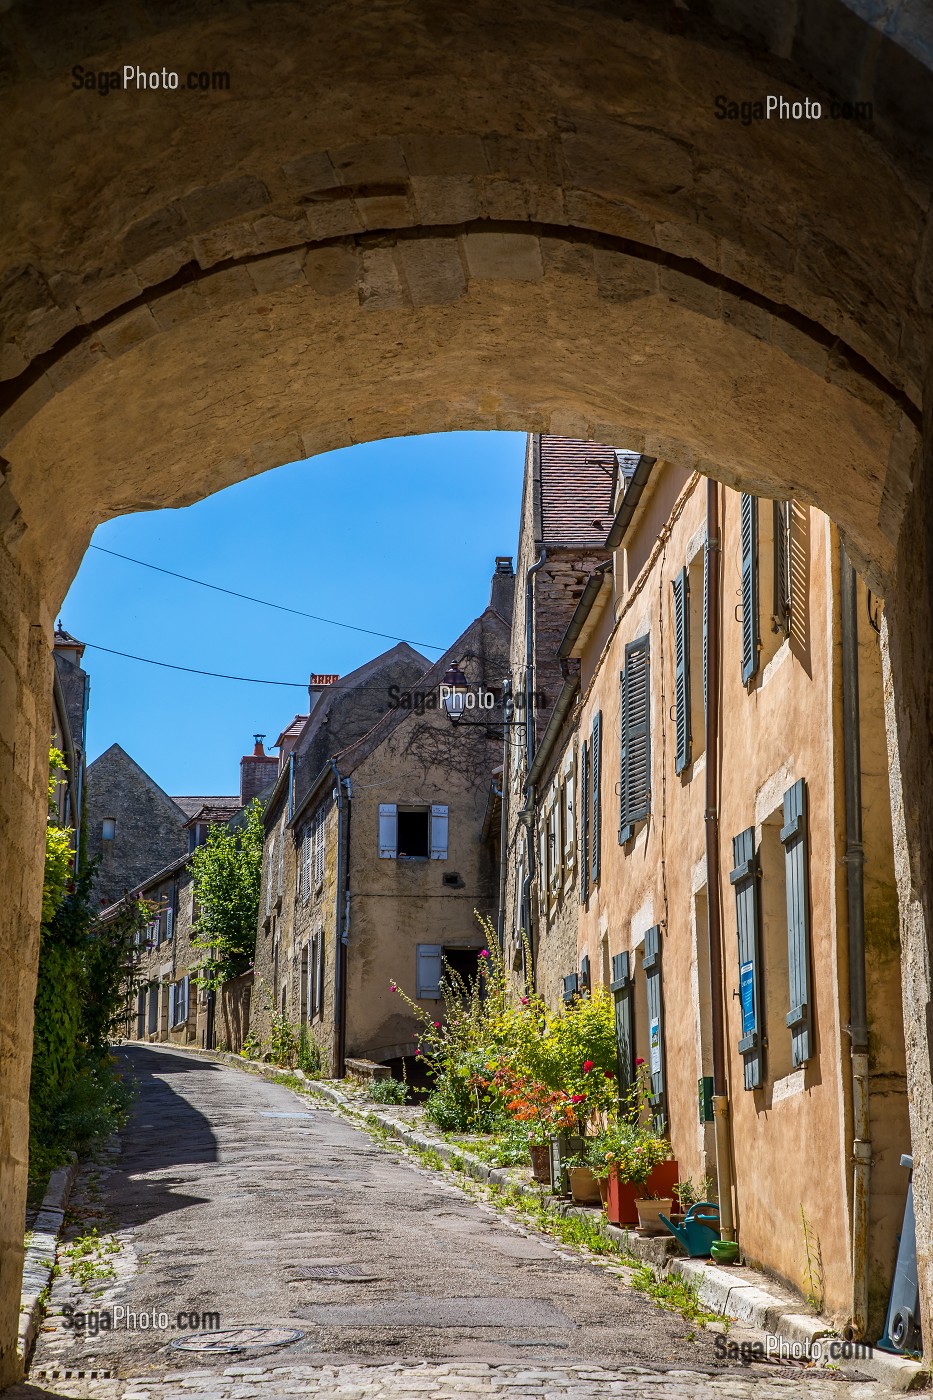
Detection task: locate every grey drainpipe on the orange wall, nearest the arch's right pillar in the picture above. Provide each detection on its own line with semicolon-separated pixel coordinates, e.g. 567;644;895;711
839;540;871;1338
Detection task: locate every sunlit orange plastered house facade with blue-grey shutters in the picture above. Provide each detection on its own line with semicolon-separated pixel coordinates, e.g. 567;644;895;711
512;436;911;1336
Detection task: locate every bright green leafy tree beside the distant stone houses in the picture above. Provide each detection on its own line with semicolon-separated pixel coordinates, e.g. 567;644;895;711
191;799;263;990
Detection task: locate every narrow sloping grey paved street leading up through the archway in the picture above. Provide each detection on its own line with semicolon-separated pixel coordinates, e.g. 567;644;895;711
10;1046;884;1400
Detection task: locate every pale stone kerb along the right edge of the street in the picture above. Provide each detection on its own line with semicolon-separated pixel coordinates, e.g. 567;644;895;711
123;1043;929;1390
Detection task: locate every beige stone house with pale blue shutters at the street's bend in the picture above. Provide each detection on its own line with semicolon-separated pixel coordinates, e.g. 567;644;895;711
254;581;510;1072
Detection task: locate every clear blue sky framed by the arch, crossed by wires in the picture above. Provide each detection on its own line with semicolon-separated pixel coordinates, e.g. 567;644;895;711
60;433;525;794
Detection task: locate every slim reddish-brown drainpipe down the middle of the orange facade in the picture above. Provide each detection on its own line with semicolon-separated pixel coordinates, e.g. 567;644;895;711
705;480;735;1239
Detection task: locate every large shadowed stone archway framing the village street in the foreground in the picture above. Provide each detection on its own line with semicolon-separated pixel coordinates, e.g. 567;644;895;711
0;0;933;1382
